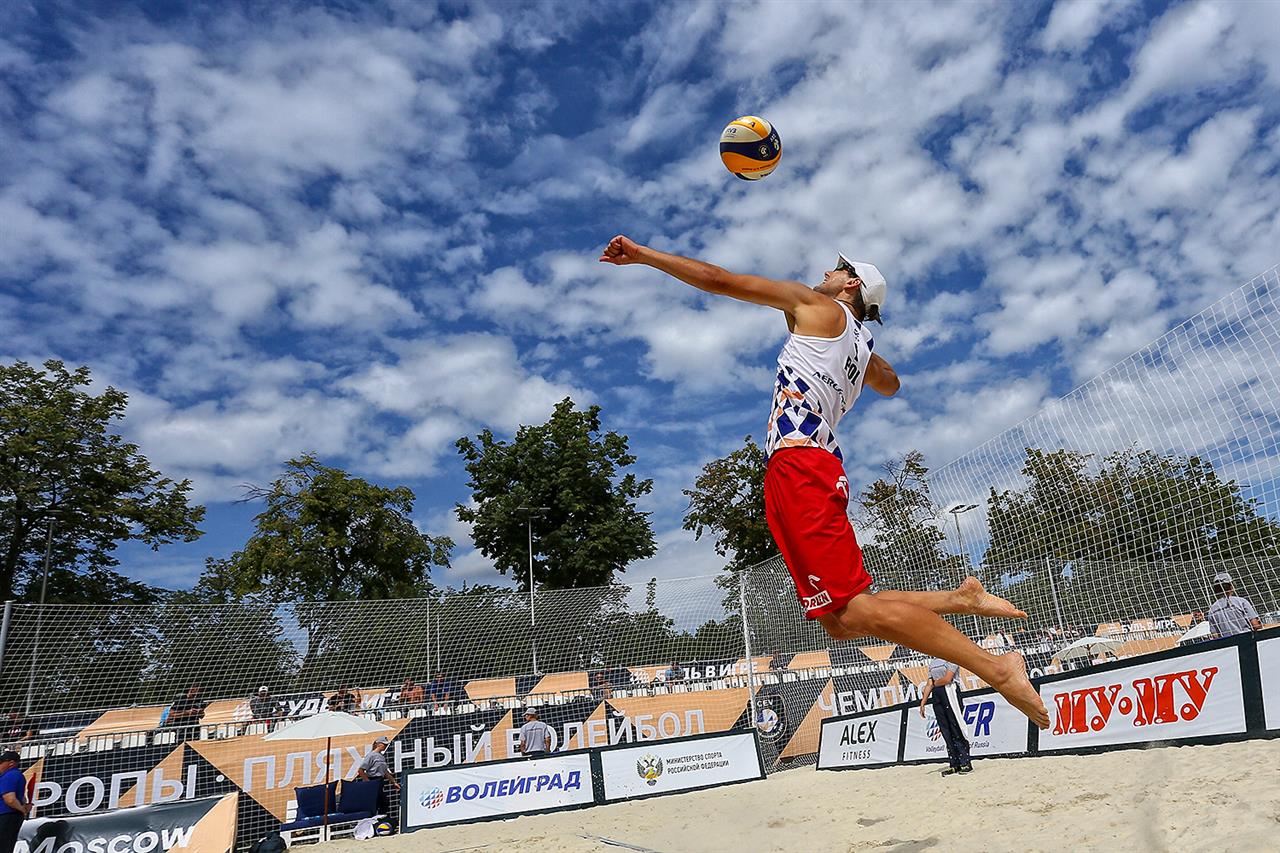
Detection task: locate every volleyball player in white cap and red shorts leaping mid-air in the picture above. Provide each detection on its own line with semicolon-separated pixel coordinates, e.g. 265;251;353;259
600;234;1048;729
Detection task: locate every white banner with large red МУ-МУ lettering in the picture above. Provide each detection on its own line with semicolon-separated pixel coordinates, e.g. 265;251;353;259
1039;646;1244;752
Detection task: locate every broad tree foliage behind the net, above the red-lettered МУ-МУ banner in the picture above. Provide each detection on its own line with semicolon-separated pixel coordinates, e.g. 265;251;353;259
984;440;1280;622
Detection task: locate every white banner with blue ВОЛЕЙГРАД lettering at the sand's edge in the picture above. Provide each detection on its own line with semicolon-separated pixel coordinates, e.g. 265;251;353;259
403;753;595;830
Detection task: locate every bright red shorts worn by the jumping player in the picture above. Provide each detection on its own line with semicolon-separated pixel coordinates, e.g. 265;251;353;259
764;447;872;619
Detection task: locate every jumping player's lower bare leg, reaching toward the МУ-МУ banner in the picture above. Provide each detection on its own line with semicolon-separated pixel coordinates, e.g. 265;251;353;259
818;593;1048;729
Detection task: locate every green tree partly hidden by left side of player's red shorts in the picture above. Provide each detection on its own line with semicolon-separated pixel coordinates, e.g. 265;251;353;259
685;435;778;571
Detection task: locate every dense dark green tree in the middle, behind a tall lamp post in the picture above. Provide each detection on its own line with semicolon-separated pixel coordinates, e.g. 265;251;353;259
457;398;657;589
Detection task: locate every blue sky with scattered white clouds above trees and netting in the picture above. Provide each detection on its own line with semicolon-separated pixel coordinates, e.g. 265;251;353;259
0;0;1280;587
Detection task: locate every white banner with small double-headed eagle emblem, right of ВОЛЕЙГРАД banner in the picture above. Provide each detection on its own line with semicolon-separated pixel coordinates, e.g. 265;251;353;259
600;733;764;802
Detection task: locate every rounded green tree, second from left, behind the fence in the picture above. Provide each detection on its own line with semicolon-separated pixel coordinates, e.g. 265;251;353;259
201;455;453;602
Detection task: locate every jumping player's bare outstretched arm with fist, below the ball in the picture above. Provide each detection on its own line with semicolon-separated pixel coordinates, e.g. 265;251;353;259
600;234;831;315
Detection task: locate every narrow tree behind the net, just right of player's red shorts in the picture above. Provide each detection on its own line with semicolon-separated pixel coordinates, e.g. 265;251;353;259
858;451;968;589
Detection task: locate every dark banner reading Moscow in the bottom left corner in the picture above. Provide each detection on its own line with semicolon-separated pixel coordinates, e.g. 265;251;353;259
15;794;238;853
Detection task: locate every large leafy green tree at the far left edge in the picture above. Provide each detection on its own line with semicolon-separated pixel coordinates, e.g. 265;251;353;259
0;360;205;603
